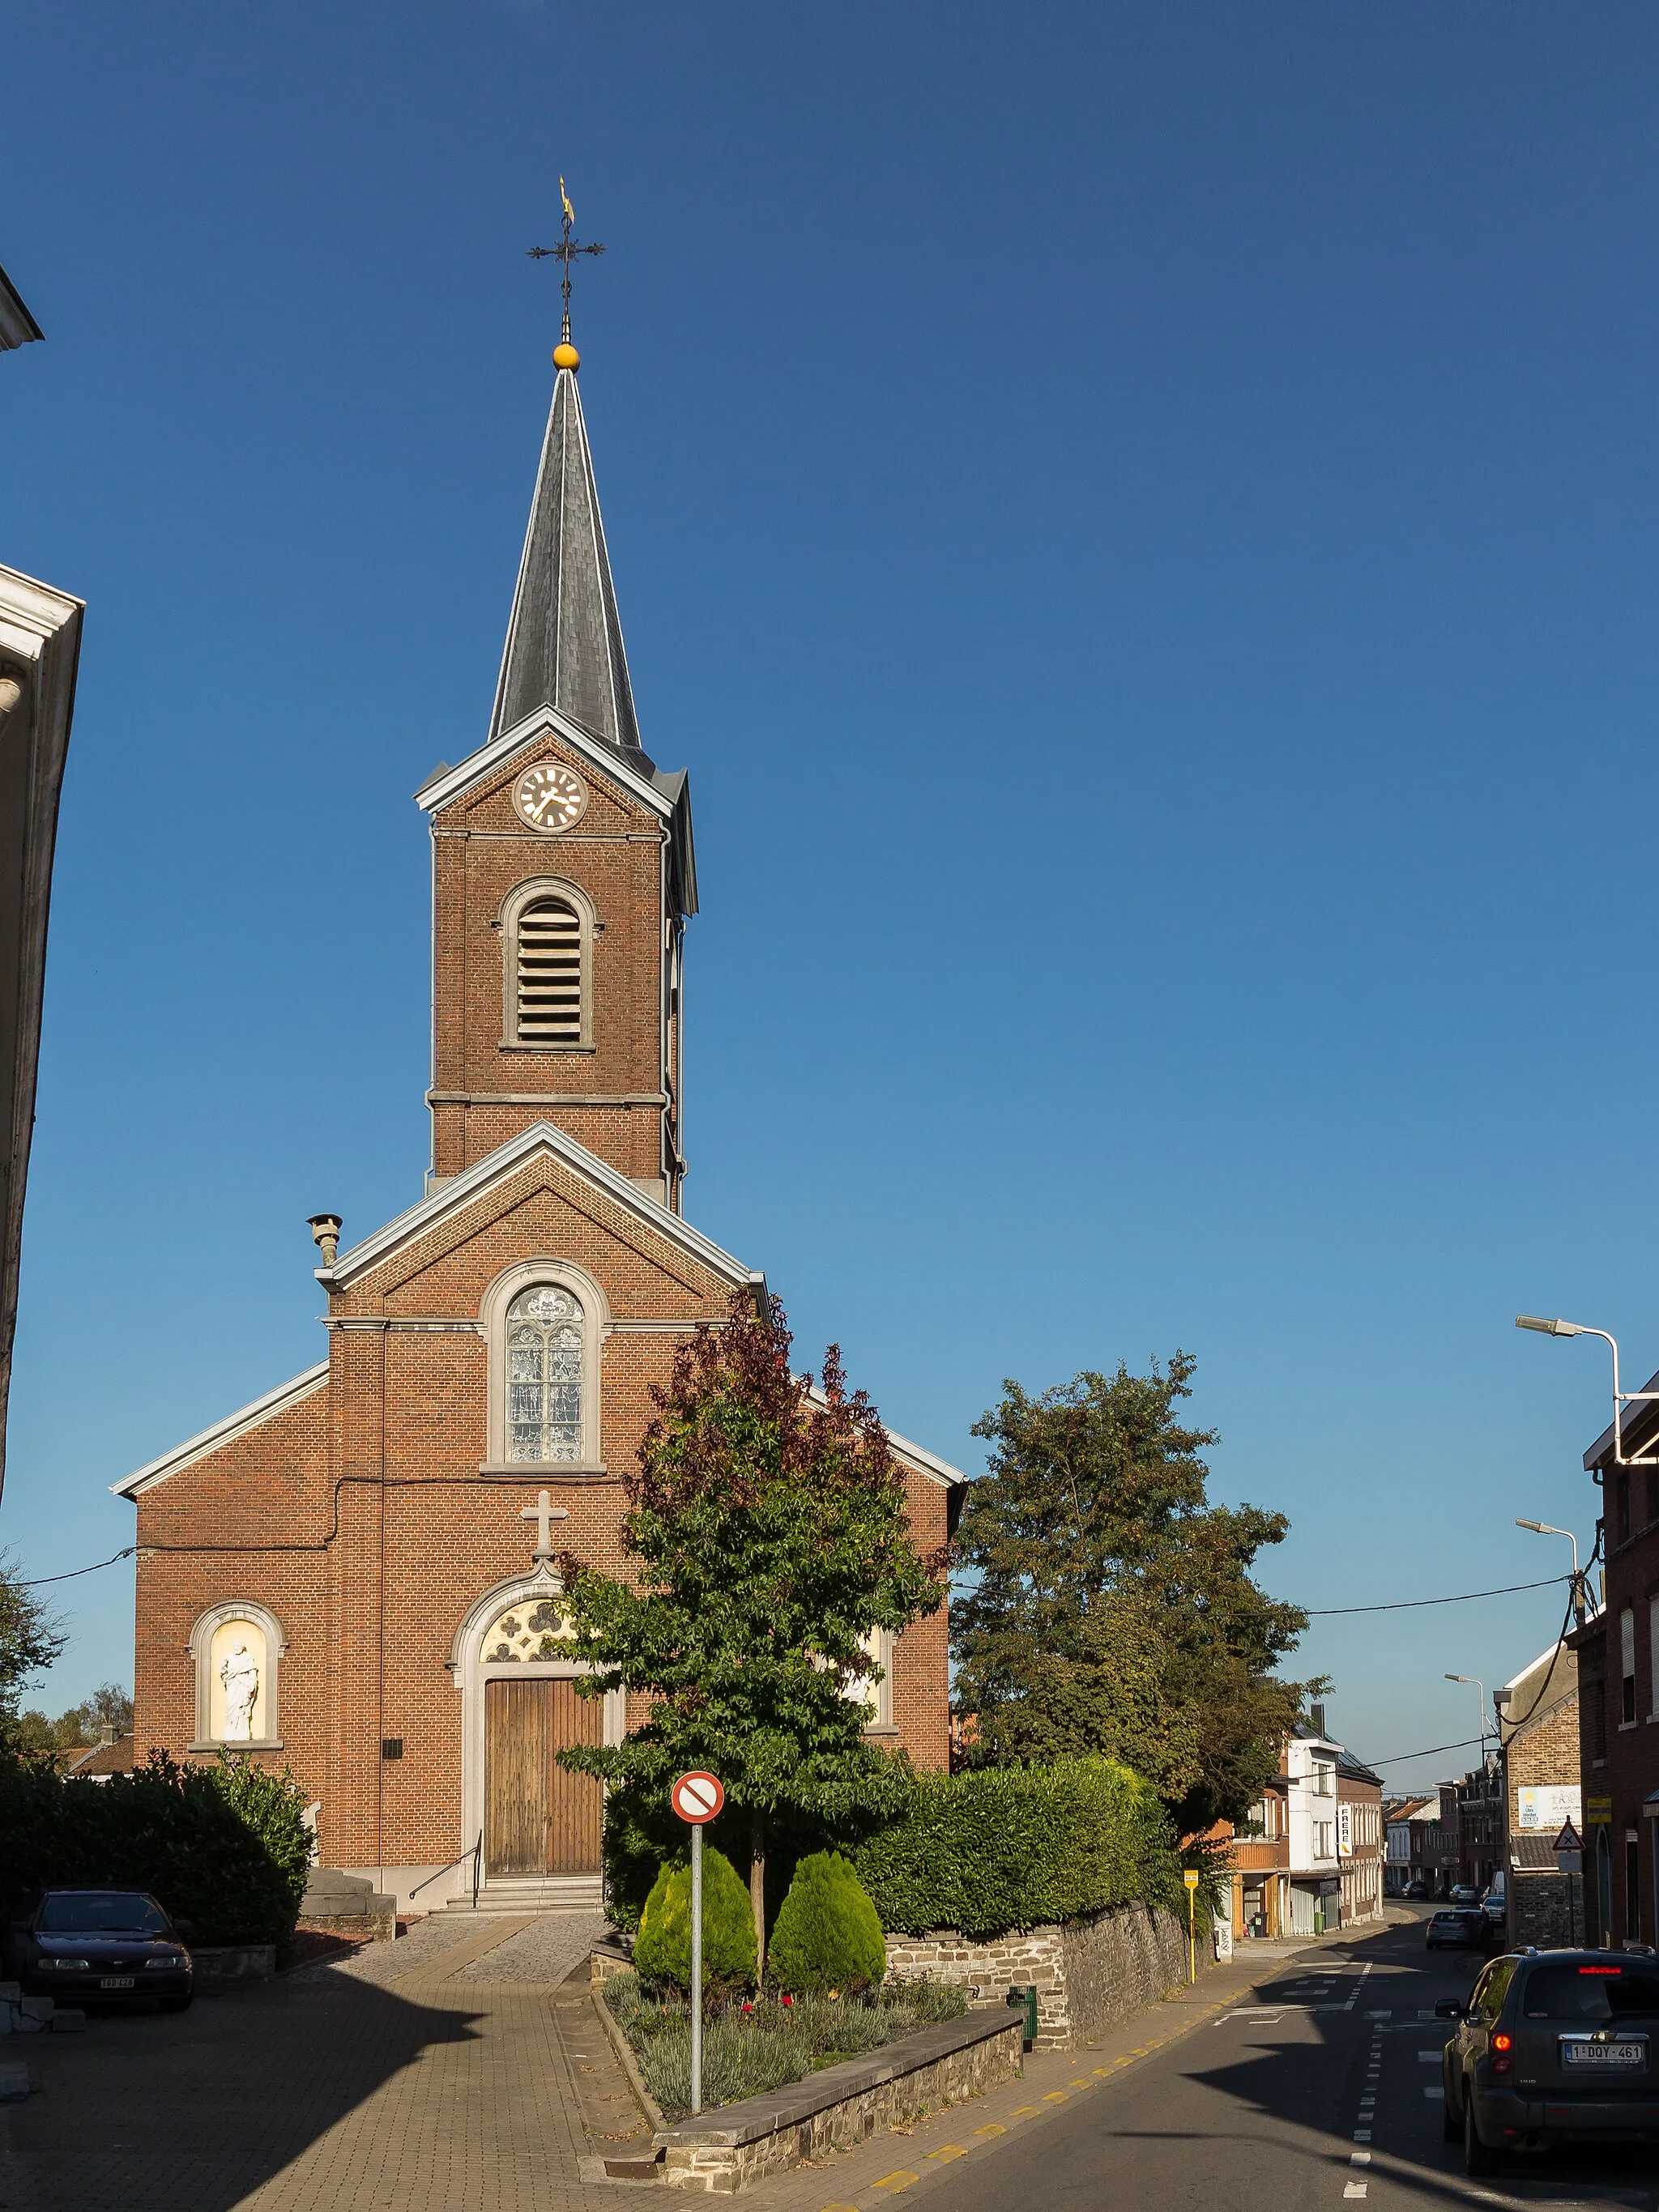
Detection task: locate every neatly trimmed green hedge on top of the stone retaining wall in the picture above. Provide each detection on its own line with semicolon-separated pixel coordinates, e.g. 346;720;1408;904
851;1758;1186;1937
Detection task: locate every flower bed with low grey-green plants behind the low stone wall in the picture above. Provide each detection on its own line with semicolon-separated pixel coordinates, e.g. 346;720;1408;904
603;1973;966;2115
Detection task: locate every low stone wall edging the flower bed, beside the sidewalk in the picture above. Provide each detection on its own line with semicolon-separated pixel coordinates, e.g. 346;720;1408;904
655;2013;1020;2197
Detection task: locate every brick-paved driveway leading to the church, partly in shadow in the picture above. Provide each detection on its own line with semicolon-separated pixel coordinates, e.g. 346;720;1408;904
0;1920;648;2212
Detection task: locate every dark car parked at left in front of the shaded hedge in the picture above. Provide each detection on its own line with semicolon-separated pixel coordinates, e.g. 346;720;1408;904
2;1889;194;2013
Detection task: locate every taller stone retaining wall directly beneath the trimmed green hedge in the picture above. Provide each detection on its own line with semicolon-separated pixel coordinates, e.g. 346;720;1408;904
887;1904;1212;2048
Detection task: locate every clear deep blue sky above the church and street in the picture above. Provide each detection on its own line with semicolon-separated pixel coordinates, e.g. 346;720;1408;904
0;0;1659;1780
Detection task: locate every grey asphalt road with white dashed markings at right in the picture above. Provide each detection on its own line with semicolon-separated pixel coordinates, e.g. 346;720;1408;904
927;1912;1659;2212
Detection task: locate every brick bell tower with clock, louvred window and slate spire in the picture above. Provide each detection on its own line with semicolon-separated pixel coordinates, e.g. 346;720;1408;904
416;322;697;1213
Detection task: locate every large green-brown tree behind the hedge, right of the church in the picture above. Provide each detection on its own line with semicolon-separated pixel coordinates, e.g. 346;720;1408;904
951;1352;1311;1831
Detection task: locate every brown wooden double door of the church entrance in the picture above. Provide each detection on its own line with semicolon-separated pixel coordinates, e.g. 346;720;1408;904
484;1677;603;1876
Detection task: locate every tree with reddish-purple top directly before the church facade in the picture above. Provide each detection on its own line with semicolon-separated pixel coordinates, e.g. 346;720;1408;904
560;1298;945;1962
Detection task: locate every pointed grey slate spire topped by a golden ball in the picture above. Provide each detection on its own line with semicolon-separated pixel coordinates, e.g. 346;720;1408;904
488;362;653;777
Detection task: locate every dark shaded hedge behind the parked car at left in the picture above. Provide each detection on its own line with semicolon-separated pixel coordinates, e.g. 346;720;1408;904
0;1752;309;1945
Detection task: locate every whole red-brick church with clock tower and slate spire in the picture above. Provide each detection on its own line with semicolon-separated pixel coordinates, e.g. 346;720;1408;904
117;347;962;1907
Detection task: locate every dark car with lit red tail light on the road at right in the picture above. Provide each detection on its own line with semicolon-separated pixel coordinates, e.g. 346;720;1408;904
1433;1951;1659;2175
